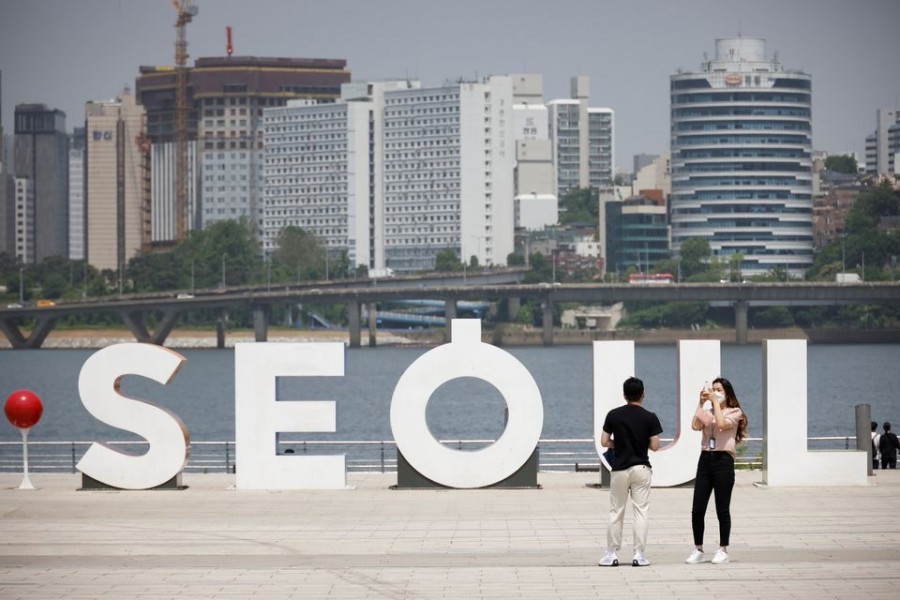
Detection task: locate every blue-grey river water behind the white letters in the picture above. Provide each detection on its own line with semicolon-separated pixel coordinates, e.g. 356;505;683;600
0;344;900;441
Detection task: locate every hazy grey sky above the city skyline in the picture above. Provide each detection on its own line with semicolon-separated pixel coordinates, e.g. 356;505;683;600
0;0;900;170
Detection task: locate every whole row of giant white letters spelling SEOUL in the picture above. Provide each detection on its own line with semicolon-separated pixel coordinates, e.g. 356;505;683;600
77;319;868;490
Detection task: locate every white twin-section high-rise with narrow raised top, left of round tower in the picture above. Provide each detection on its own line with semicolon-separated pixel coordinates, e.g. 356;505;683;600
547;76;615;198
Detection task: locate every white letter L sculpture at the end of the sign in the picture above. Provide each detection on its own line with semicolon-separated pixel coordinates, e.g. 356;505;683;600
763;340;869;487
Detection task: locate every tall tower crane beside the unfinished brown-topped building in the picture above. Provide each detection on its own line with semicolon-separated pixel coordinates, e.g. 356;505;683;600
172;0;197;242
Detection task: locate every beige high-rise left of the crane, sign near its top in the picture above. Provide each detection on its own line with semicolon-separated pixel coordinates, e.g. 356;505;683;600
84;90;149;276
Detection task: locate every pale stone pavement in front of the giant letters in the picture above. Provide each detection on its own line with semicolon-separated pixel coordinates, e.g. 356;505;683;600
0;471;900;600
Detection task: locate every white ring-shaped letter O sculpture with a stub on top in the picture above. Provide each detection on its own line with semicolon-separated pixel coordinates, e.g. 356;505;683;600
391;319;544;488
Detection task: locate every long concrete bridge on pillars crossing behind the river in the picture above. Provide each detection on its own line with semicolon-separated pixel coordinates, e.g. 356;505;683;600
0;272;900;349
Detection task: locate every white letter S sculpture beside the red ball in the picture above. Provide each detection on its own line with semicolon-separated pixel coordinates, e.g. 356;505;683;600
77;343;191;490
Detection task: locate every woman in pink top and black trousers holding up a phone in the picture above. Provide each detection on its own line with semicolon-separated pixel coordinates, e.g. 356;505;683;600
685;377;747;565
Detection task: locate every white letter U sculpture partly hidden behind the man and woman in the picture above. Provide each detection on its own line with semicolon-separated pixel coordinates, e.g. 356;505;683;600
594;340;721;487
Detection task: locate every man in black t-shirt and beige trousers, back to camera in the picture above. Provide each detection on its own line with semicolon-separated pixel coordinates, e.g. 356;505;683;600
600;377;662;567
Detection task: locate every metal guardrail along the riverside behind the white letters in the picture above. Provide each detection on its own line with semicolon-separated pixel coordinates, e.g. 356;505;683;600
0;435;856;473
